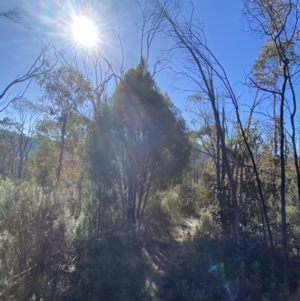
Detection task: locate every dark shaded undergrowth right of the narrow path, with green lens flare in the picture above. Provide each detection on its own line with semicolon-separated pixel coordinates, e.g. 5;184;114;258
162;227;296;301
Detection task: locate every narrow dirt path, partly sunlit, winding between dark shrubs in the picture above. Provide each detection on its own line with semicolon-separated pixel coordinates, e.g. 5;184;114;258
143;218;199;301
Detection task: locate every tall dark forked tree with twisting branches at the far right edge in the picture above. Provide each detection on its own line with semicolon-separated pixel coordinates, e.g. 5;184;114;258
243;0;300;287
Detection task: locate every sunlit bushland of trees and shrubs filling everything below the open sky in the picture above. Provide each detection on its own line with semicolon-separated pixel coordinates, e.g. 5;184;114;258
0;0;300;301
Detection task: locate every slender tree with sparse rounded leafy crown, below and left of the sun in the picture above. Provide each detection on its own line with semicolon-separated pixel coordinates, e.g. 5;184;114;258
37;66;91;182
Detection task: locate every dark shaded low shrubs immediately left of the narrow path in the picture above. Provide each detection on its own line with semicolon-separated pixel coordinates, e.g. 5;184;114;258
62;235;145;301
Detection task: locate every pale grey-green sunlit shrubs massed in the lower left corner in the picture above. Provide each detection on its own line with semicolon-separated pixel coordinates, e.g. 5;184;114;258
0;180;81;300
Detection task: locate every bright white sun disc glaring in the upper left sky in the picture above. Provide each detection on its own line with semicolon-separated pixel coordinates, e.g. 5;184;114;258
72;17;98;47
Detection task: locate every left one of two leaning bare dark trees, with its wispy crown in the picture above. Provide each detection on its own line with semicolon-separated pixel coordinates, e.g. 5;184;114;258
150;0;245;246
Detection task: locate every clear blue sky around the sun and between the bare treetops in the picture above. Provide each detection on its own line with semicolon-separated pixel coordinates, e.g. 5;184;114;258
0;0;262;120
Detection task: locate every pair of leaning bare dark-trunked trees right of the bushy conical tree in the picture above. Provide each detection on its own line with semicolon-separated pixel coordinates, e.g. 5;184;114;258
150;0;274;272
